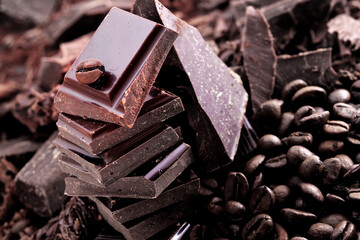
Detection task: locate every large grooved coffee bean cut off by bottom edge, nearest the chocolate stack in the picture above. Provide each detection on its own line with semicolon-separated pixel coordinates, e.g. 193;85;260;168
242;214;274;240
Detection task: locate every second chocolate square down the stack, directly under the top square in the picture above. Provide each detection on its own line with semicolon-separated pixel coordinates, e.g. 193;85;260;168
57;87;184;155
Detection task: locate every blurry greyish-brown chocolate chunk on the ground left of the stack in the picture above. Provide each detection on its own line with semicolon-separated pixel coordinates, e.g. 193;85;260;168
15;133;66;217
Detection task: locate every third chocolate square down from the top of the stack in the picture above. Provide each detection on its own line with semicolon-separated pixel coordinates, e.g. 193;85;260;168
55;124;181;186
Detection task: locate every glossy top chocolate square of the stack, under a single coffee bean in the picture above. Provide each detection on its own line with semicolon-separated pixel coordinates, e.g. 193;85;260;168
54;8;177;128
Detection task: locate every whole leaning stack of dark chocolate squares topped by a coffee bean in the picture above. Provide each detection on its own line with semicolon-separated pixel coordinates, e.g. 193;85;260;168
55;8;199;239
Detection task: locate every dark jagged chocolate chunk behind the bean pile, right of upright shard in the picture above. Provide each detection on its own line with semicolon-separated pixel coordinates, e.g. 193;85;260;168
275;48;337;93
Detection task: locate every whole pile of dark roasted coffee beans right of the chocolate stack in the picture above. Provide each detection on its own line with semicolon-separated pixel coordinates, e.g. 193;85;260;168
190;76;360;240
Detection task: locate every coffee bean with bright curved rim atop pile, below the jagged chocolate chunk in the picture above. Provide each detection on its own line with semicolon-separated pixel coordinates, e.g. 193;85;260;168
291;86;326;107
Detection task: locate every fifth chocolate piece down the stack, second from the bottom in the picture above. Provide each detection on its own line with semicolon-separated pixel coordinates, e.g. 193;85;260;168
90;178;200;223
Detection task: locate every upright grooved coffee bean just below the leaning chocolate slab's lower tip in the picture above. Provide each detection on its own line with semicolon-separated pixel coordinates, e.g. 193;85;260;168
224;172;249;202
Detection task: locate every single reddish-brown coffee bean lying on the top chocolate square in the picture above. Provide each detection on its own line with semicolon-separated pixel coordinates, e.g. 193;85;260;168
75;59;105;85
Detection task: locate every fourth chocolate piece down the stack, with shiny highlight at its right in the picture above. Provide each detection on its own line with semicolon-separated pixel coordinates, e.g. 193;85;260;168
65;143;194;199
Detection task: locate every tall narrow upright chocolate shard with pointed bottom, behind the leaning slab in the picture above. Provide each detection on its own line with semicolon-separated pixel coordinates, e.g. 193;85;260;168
241;7;276;113
